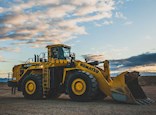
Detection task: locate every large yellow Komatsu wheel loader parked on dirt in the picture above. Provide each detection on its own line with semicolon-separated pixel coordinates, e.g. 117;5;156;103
8;44;154;104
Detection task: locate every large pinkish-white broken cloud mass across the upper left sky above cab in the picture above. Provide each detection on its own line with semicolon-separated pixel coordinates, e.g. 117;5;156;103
0;0;115;46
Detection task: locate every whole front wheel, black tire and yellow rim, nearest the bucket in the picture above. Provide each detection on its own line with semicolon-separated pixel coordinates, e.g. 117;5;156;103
66;71;98;101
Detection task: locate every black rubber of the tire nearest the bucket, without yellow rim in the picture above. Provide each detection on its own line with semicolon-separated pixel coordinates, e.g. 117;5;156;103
66;71;98;102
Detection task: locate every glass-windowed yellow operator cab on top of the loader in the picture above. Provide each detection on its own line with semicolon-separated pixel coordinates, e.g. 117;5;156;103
47;44;71;61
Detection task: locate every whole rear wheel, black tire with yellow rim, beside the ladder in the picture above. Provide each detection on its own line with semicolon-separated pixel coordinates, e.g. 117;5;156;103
22;74;43;99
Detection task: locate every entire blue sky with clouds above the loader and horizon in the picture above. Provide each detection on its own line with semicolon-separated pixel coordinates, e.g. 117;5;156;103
0;0;156;77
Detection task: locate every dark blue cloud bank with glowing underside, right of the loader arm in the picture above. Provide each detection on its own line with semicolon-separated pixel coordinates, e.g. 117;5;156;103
110;53;156;75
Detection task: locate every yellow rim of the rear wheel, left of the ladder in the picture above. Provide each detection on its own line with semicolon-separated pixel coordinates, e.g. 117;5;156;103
25;80;36;95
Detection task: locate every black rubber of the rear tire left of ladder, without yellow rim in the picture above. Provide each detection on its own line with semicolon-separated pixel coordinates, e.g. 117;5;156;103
22;74;43;100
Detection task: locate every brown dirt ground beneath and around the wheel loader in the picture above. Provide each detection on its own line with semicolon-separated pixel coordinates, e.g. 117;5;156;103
0;78;156;115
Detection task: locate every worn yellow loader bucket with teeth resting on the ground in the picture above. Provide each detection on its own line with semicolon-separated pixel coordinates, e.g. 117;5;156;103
111;72;154;105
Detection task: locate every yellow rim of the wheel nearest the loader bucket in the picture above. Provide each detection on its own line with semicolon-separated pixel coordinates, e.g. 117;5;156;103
72;78;86;95
